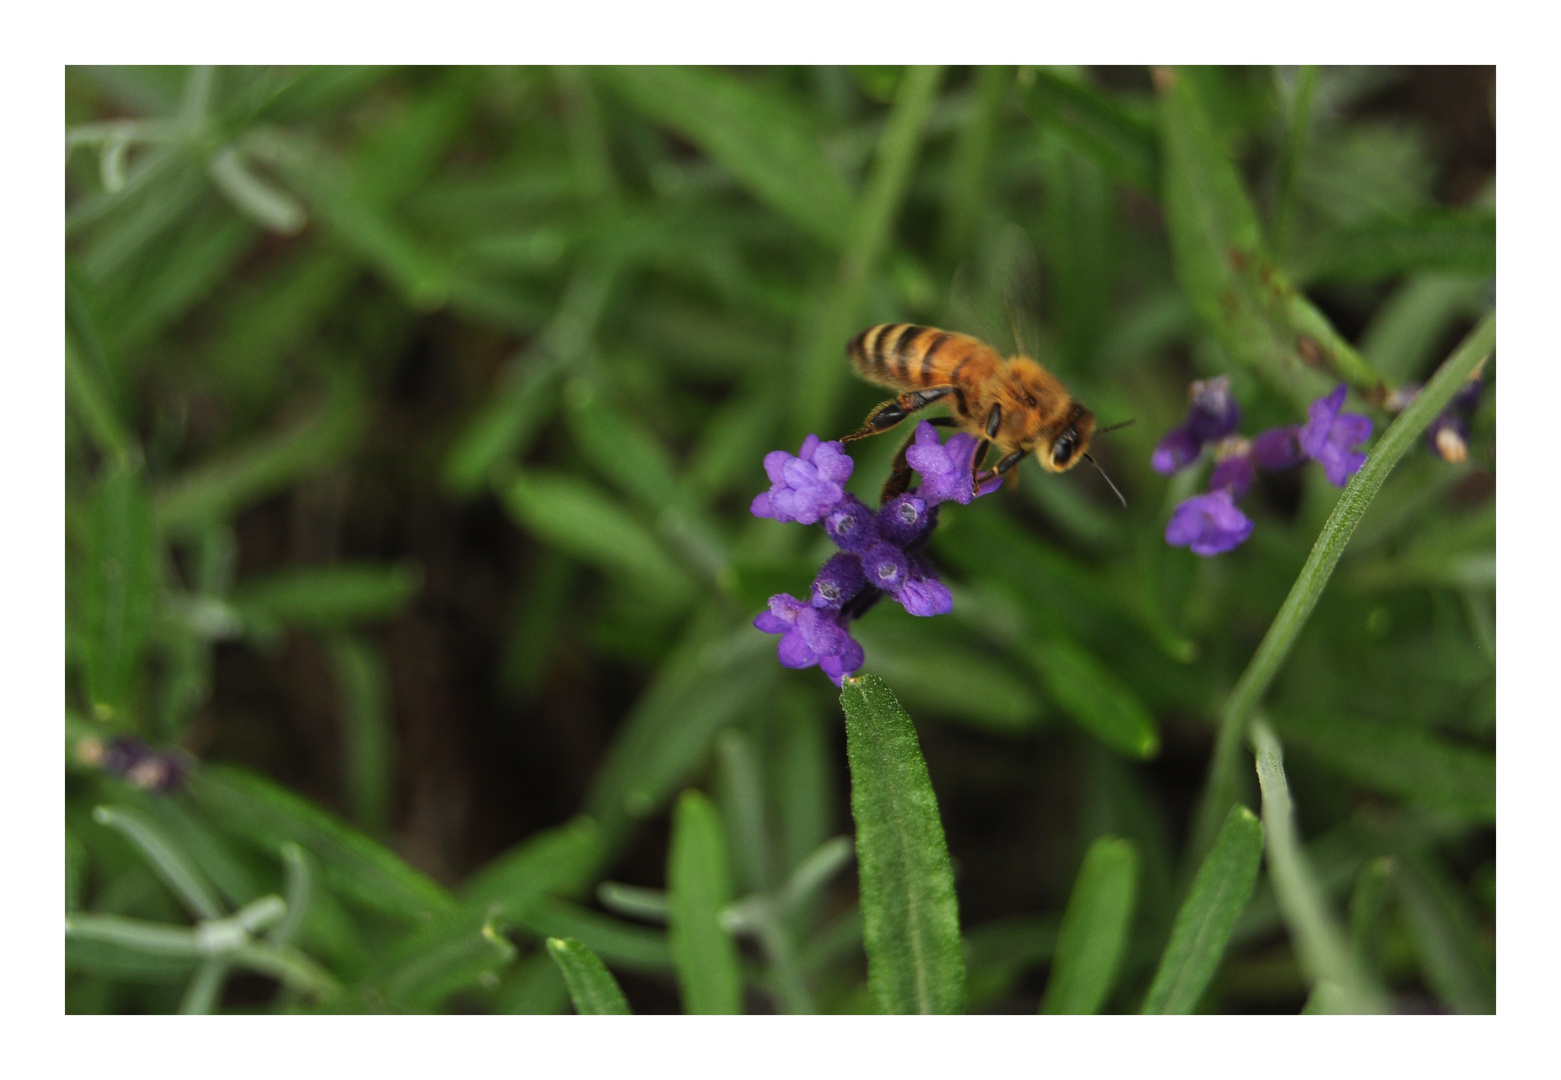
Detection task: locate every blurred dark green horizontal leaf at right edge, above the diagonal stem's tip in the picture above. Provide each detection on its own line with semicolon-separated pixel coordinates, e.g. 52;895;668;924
1297;211;1495;281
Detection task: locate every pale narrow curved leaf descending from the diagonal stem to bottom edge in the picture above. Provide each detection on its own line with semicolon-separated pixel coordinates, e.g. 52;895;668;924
1252;721;1388;1013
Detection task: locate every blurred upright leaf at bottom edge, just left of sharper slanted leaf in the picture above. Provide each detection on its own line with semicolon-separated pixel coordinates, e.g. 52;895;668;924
1041;837;1138;1016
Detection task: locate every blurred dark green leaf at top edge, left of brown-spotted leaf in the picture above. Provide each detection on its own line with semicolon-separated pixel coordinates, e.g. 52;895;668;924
1019;67;1160;195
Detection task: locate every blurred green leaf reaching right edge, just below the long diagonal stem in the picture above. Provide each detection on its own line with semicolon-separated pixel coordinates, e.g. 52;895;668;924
1274;713;1495;824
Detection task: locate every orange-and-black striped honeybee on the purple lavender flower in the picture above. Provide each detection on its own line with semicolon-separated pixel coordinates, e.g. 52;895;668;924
841;323;1127;506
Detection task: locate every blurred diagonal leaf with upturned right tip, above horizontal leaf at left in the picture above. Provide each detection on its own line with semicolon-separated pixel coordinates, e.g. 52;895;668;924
156;375;367;535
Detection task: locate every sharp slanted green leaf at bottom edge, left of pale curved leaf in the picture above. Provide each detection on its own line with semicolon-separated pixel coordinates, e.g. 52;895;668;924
1143;807;1263;1016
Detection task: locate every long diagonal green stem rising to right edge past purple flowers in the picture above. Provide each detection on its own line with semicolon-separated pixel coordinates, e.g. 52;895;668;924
1188;312;1495;866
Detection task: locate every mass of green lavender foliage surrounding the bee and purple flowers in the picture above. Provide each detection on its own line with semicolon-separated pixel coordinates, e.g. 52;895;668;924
66;67;1495;1013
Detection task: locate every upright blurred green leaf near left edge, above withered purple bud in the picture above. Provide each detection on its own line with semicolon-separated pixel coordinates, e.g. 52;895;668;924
83;465;158;719
